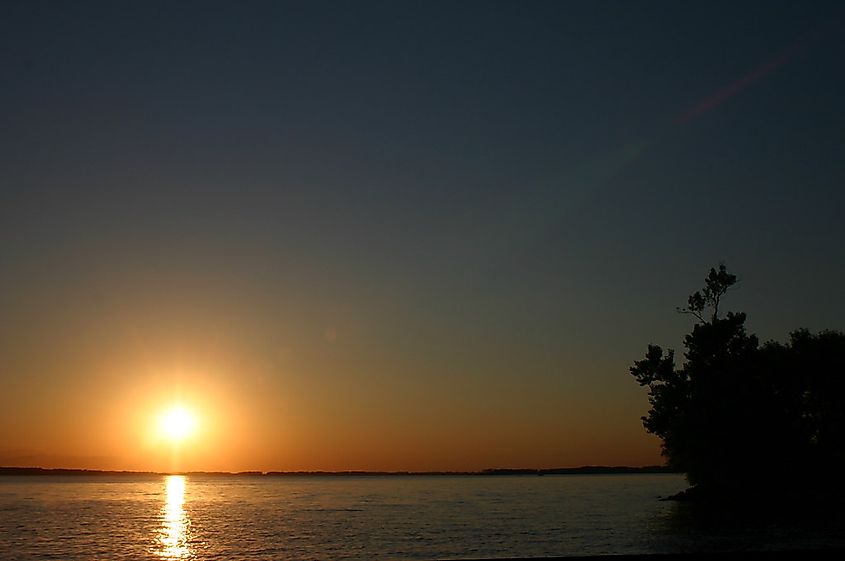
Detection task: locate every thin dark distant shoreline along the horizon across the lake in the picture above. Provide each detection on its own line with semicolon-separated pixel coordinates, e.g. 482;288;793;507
0;466;677;477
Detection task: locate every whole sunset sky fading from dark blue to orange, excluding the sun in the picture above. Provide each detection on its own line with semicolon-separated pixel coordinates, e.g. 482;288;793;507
0;0;845;471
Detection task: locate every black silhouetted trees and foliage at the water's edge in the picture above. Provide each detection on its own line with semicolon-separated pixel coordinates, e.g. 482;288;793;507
631;266;845;497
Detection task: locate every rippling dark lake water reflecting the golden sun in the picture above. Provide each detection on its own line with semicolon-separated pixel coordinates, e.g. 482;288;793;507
0;474;845;560
